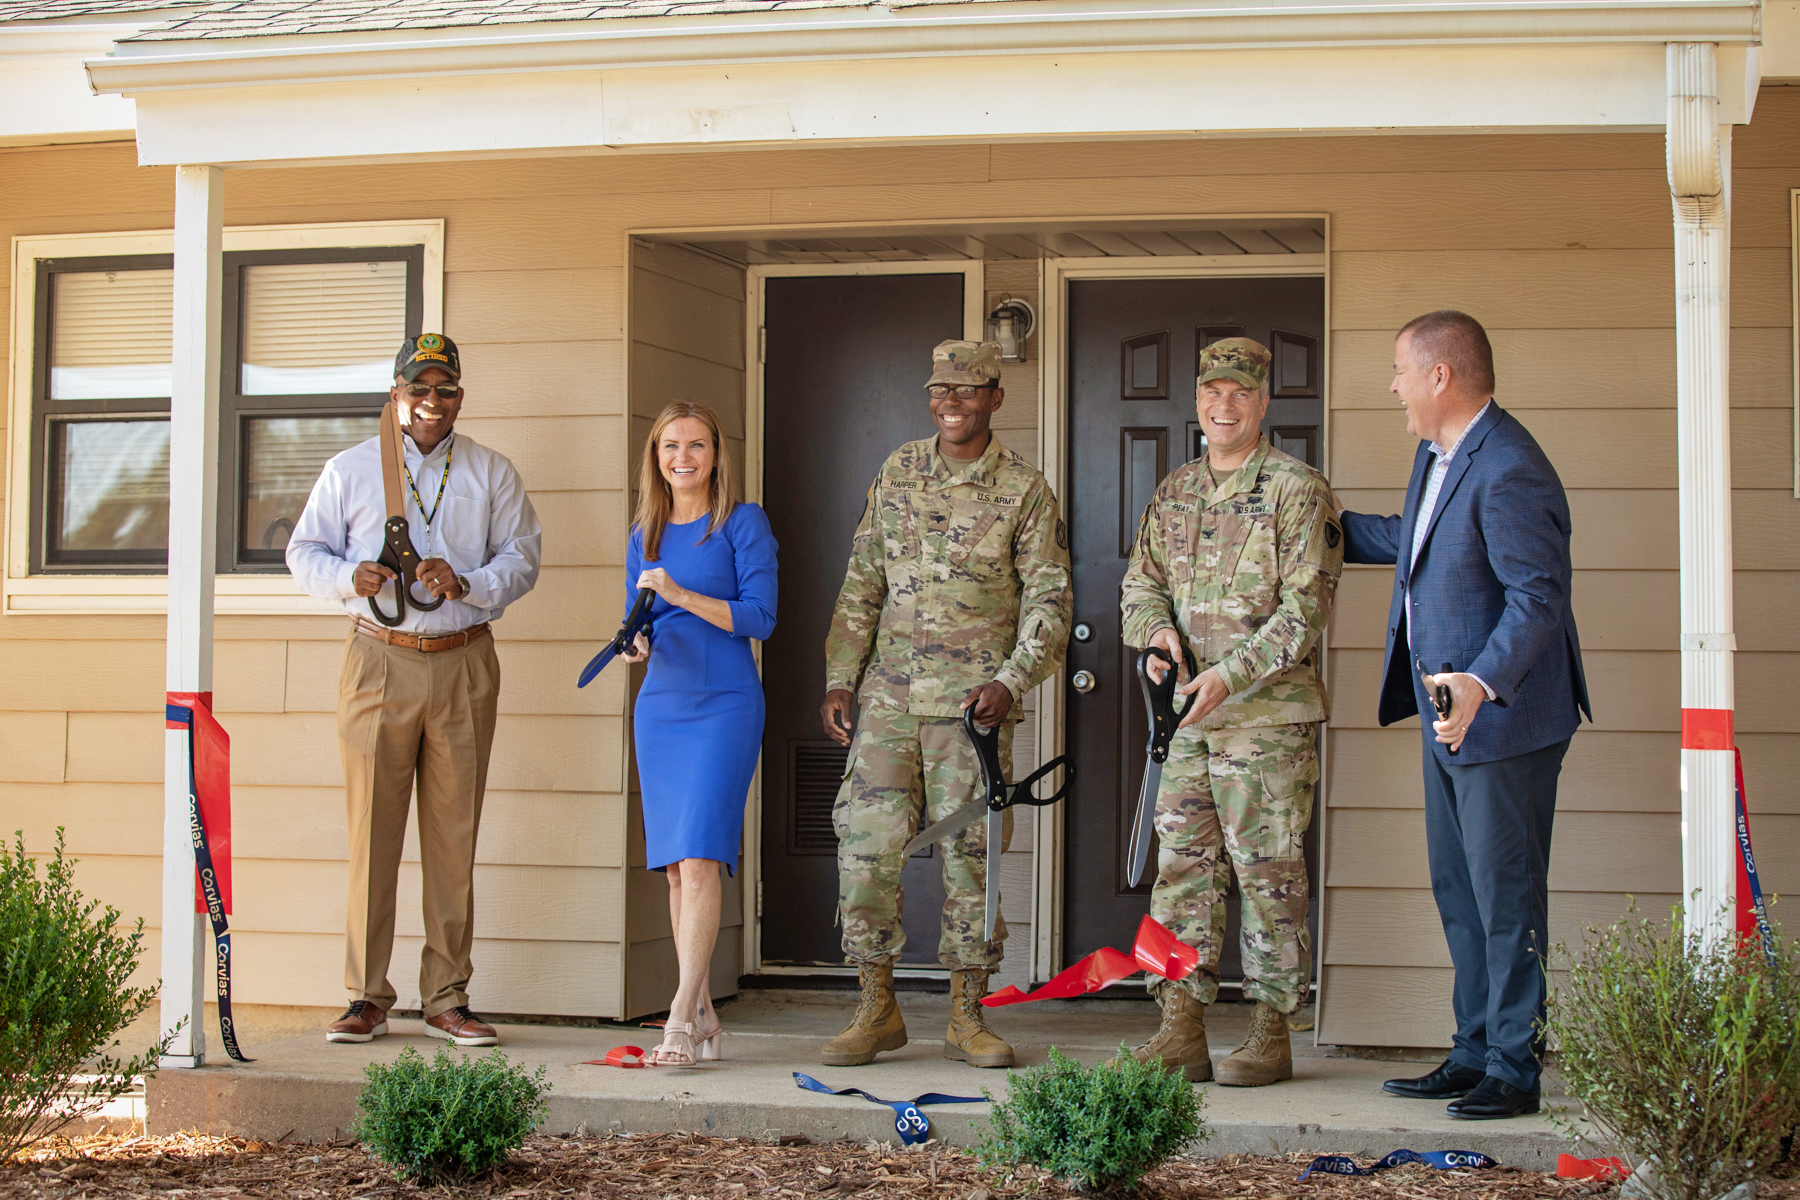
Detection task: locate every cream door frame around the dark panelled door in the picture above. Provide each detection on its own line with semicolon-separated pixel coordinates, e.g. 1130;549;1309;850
1031;246;1332;981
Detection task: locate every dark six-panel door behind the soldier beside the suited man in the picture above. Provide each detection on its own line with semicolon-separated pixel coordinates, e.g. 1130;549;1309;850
1064;279;1325;979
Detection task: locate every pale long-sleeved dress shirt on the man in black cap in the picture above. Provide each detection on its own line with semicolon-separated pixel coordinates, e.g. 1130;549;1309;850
288;434;544;633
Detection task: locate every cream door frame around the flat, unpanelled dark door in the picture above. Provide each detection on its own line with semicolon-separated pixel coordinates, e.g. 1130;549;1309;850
742;259;986;977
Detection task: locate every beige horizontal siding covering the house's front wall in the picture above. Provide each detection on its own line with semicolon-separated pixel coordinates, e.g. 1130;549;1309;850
0;88;1800;1045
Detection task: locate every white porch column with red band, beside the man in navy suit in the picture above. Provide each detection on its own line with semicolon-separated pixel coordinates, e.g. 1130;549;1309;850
1669;43;1737;937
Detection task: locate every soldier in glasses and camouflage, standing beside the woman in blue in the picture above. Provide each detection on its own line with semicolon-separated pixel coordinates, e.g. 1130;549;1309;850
821;342;1073;1067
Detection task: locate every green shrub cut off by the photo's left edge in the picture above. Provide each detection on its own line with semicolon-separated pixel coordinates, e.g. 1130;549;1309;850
0;829;169;1162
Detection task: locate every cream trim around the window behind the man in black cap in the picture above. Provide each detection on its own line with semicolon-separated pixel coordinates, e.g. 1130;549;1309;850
0;218;445;615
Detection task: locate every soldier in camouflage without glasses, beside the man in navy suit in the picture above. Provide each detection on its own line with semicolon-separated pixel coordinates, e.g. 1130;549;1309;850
1120;338;1345;1087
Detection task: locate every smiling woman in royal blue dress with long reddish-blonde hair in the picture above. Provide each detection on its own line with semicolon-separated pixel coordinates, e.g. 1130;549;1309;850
625;401;776;1067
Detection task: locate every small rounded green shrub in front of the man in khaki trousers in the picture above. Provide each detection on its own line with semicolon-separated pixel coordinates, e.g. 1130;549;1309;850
351;1045;551;1184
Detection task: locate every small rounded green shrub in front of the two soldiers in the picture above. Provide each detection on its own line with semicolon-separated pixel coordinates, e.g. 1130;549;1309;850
981;1045;1208;1191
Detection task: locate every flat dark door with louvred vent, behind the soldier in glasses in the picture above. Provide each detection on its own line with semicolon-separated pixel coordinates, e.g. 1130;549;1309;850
761;273;963;964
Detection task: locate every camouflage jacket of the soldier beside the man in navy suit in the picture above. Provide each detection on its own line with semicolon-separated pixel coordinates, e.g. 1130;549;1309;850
1120;439;1345;729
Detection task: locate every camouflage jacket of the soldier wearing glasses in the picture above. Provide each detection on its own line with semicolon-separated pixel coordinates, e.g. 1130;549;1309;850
824;437;1073;720
